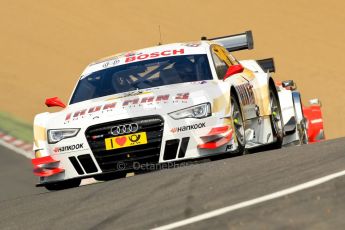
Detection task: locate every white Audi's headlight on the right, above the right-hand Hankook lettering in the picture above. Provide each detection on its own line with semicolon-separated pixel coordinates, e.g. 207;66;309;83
169;103;211;120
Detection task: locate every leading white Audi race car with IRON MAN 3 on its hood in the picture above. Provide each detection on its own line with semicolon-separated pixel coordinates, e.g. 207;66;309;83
32;32;322;190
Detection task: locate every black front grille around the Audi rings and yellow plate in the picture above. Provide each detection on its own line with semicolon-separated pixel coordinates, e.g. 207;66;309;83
85;116;164;172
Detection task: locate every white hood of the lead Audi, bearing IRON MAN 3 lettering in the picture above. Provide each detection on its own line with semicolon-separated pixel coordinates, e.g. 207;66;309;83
46;81;225;128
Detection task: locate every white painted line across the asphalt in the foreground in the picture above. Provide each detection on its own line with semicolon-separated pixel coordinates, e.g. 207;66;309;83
154;170;345;230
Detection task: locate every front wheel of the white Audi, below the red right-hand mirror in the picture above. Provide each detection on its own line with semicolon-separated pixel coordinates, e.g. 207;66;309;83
230;92;246;155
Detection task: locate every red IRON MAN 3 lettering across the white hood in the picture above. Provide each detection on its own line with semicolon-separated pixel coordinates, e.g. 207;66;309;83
65;93;189;122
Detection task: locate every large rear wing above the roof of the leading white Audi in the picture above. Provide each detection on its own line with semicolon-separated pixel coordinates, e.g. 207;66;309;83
201;30;254;52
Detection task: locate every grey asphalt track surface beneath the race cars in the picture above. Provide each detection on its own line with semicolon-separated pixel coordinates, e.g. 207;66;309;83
0;138;345;229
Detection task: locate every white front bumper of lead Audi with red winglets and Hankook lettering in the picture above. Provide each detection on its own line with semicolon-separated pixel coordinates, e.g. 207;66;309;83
33;112;237;184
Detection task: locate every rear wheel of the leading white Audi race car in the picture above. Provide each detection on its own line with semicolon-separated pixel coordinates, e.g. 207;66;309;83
269;84;284;149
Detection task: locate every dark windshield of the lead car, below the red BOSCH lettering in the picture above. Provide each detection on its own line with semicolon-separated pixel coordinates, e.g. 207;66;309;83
70;54;212;104
